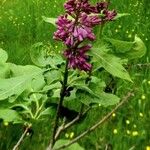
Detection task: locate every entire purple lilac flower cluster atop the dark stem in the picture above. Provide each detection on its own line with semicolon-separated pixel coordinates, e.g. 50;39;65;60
54;0;116;71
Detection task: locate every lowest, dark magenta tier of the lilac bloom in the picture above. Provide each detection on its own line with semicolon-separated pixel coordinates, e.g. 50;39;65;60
64;45;92;71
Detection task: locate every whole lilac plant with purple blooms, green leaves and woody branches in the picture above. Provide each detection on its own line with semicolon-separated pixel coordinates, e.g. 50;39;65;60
0;0;146;150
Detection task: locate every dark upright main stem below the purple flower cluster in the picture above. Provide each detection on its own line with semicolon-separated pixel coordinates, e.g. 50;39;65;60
47;60;68;150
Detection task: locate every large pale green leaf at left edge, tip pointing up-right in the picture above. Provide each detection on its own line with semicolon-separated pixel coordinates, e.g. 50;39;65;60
0;66;43;100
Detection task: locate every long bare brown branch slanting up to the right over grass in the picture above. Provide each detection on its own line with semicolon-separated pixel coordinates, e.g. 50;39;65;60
54;92;134;150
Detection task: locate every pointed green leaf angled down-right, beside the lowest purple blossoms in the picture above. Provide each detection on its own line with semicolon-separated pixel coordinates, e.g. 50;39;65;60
91;46;132;81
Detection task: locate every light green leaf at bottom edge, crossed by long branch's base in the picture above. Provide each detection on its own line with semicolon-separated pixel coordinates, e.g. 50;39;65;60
54;139;84;150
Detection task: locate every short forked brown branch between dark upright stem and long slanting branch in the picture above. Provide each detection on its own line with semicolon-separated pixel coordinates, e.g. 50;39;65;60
55;105;90;140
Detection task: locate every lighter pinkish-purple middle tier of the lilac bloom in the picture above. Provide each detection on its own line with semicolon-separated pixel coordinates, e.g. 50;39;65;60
54;14;97;47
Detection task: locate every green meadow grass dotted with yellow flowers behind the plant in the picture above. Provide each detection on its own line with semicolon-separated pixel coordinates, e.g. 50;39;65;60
0;0;150;150
